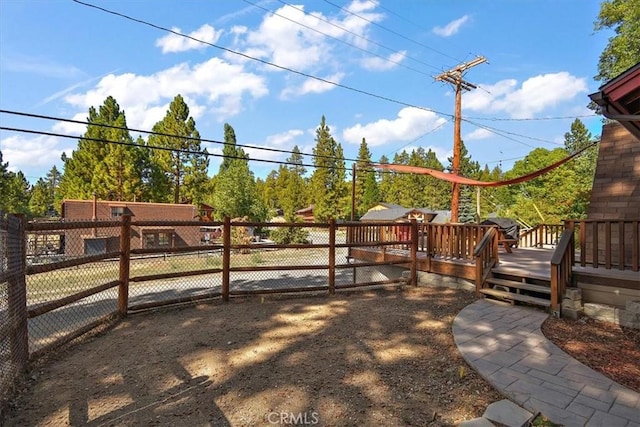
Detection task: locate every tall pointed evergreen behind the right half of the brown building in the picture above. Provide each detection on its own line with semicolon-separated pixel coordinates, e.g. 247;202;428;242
148;95;209;203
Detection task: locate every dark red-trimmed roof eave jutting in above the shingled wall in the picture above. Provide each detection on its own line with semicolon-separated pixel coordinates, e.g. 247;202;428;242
589;62;640;140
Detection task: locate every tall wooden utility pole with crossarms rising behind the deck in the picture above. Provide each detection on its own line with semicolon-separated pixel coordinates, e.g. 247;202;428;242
436;56;487;222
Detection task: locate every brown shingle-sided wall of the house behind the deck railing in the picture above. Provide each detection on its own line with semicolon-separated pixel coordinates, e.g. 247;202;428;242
587;123;640;263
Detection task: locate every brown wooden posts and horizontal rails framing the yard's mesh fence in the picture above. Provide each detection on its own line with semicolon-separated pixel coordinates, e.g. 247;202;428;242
0;215;418;367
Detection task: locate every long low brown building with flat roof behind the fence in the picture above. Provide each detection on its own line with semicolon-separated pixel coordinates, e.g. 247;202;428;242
62;200;202;256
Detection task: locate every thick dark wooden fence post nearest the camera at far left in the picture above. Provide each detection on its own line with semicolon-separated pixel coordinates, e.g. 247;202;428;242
7;214;29;371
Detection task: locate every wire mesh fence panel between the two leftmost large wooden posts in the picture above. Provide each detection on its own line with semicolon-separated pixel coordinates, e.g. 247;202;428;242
26;222;121;355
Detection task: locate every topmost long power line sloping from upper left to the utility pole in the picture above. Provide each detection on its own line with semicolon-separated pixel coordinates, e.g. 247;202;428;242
71;0;452;117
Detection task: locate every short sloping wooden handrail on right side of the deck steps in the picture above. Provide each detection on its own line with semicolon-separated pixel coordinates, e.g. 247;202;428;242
551;228;575;317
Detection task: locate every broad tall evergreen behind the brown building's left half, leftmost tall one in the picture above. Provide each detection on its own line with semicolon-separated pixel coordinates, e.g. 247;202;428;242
60;96;141;200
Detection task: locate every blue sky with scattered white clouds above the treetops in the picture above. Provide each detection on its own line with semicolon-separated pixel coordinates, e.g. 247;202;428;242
0;0;611;182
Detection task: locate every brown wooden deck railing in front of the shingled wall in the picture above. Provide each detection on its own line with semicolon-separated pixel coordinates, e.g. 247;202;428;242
565;220;640;271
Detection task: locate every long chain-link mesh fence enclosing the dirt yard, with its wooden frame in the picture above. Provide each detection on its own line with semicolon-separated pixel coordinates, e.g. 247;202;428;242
0;215;416;412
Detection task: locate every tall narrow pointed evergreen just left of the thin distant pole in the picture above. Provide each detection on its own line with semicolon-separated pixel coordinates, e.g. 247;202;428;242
310;116;349;221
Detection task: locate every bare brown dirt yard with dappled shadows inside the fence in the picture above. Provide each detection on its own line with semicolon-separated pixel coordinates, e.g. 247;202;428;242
5;288;501;426
